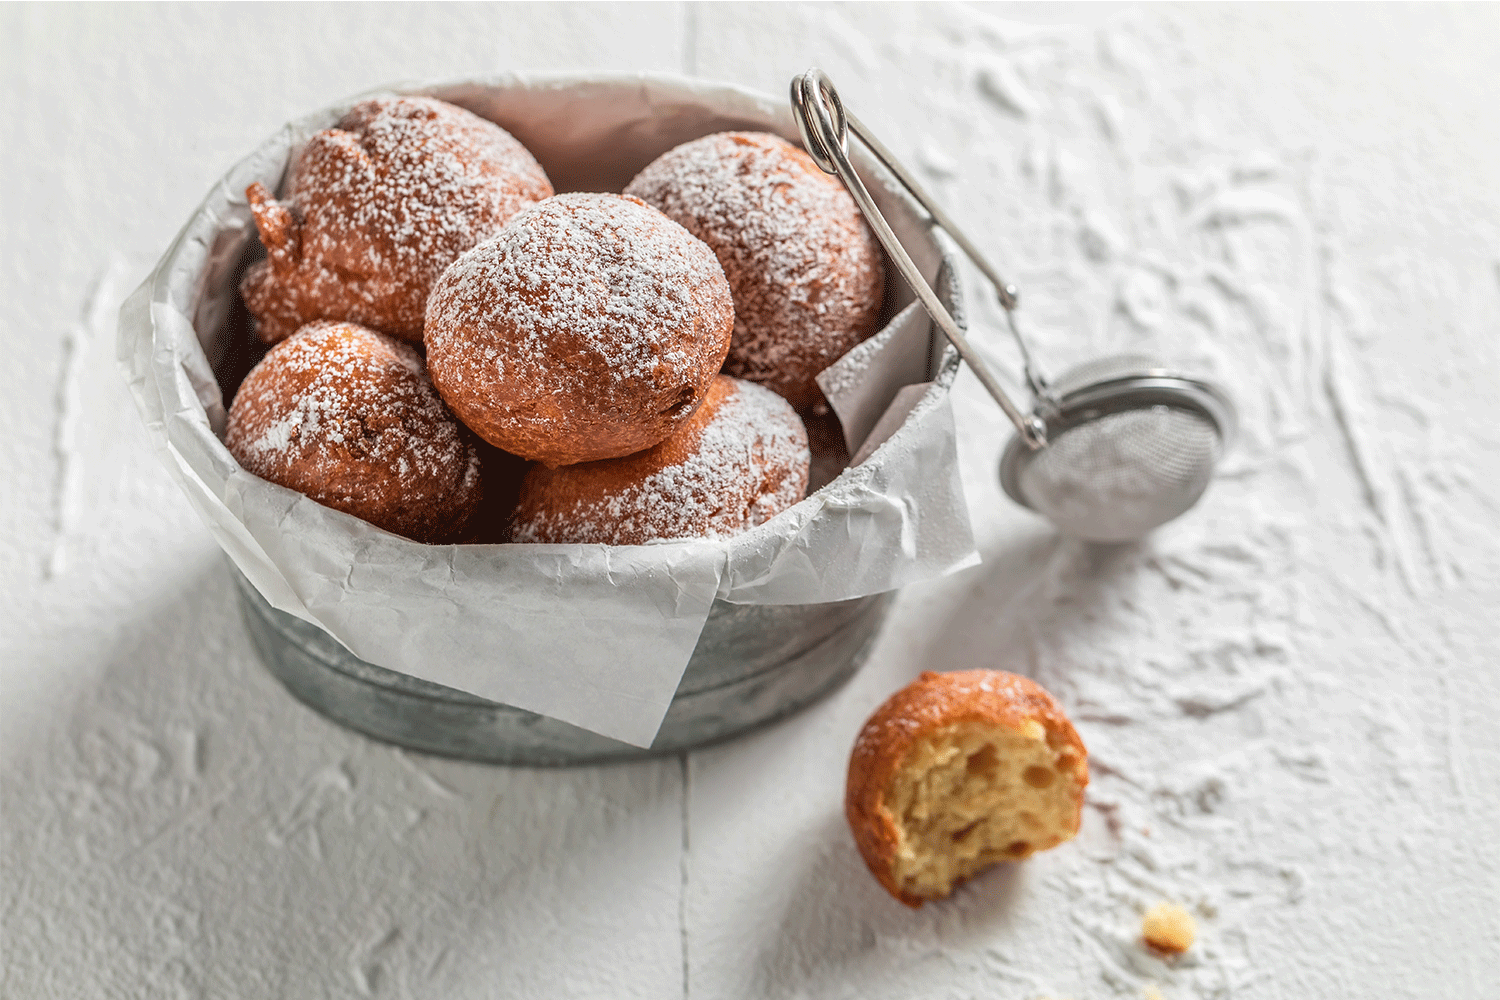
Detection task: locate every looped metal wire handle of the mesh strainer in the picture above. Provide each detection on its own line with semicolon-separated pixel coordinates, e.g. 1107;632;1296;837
792;67;1047;450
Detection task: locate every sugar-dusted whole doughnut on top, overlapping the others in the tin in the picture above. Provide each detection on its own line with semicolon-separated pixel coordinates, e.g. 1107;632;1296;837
426;193;734;466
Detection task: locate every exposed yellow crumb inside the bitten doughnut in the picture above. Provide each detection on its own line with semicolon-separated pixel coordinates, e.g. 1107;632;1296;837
885;720;1083;900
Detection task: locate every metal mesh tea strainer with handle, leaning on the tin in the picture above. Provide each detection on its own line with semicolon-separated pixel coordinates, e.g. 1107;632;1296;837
792;69;1235;541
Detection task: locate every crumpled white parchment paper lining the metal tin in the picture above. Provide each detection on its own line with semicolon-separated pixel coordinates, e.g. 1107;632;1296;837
119;76;978;747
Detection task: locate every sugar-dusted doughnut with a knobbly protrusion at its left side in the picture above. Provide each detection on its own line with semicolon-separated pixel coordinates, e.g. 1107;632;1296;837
240;97;552;343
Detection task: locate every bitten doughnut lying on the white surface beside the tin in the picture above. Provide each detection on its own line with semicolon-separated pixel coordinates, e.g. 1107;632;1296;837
845;670;1089;907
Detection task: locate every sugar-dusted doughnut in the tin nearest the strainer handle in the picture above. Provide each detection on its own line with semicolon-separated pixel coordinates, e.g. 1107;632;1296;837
626;132;885;412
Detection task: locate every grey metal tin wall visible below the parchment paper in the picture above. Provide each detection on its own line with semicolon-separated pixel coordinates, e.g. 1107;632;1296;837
234;570;893;765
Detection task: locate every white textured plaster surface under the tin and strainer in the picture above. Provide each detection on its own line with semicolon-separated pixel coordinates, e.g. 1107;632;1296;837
0;4;1500;1000
